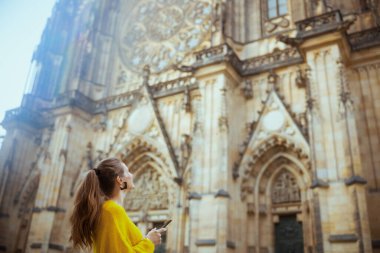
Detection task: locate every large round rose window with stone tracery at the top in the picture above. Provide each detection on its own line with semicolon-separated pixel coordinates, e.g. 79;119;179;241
119;0;214;73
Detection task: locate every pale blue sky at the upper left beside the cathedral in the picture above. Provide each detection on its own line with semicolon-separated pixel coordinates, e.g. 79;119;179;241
0;0;56;138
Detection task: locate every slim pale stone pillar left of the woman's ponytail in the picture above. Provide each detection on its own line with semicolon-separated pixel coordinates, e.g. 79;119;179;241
26;116;71;252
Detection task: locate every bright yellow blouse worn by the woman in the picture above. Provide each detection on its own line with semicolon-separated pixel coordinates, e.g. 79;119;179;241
93;200;154;253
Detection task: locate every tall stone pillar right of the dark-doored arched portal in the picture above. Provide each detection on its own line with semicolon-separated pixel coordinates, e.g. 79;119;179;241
306;44;371;253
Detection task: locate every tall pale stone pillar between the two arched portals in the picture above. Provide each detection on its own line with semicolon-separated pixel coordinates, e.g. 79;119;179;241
190;67;233;253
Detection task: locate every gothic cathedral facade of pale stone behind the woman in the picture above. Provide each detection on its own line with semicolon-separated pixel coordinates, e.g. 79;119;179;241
0;0;380;253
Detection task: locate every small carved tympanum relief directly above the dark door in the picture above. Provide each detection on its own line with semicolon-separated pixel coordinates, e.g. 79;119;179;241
272;171;301;204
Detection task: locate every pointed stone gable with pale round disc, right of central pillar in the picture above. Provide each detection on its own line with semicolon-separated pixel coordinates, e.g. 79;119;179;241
235;90;310;182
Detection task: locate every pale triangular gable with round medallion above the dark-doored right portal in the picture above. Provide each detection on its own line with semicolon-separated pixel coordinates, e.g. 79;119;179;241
238;90;310;200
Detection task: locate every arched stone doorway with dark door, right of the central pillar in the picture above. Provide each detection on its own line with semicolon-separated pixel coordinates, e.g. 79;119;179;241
241;137;314;253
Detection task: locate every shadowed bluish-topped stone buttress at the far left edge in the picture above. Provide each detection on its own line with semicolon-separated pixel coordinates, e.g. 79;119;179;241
0;121;39;252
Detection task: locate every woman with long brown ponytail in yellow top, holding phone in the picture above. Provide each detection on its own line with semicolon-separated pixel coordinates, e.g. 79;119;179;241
70;158;166;253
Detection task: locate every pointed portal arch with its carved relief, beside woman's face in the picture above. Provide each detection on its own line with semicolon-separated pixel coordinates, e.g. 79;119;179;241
116;137;177;219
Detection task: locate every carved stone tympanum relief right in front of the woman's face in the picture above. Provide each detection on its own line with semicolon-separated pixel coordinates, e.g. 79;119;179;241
124;167;169;211
